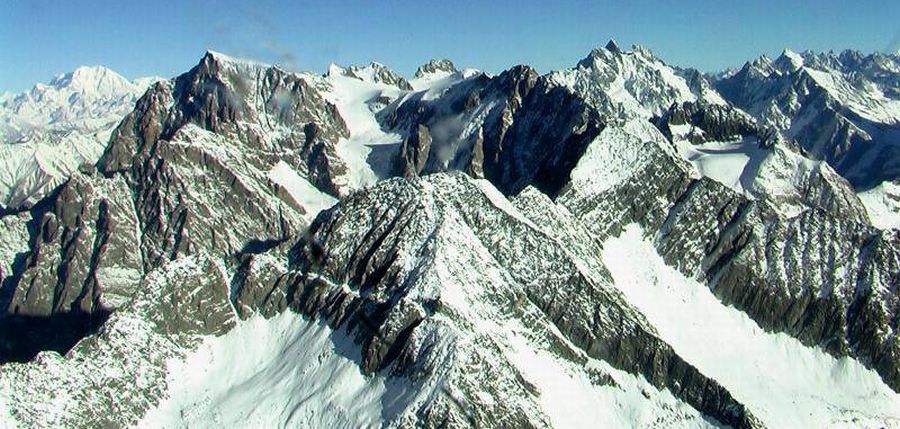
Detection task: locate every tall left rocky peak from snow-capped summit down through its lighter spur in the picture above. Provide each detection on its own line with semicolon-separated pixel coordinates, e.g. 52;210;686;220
98;49;347;269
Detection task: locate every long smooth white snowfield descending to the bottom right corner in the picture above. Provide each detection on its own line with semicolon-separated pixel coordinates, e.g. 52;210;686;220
603;224;900;427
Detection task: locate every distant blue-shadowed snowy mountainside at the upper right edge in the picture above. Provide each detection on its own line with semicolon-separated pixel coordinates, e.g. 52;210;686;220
714;50;900;190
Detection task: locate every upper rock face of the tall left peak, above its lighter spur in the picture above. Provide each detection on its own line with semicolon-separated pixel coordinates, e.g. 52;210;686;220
98;49;347;195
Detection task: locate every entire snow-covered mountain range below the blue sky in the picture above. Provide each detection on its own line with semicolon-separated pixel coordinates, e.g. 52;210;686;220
0;42;900;428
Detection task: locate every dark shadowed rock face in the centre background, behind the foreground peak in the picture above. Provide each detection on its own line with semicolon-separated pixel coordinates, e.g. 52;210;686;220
384;66;603;194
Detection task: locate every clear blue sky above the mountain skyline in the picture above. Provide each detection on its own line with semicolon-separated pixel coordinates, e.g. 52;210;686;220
0;0;900;92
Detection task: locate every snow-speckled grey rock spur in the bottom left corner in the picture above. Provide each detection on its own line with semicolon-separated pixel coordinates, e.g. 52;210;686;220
0;255;236;428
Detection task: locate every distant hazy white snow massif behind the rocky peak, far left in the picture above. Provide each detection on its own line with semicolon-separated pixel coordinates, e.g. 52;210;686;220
0;66;159;209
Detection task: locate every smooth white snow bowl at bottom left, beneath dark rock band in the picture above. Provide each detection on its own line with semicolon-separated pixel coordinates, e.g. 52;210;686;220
138;311;387;428
